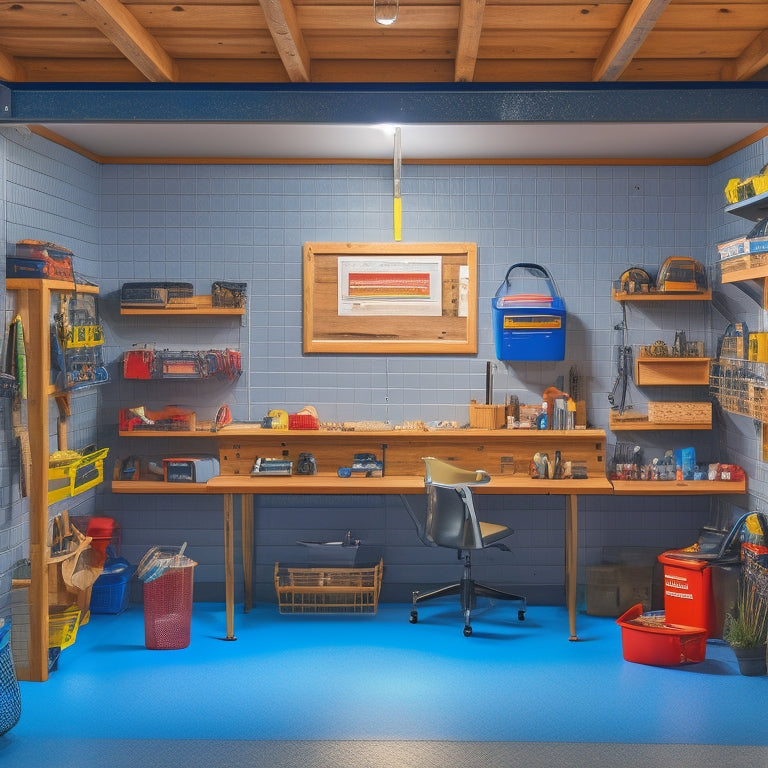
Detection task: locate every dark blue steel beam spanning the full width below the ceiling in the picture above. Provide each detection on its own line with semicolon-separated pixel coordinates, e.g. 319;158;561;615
0;82;768;125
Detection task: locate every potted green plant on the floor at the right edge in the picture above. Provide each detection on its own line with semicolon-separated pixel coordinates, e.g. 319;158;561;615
723;577;768;675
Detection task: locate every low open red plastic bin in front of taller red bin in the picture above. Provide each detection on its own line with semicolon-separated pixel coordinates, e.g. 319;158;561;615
616;603;707;667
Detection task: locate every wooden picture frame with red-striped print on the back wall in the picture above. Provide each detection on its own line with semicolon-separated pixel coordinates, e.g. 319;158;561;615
304;242;477;355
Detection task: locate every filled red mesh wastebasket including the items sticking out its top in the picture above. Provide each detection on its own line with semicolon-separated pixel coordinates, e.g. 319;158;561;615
136;544;197;650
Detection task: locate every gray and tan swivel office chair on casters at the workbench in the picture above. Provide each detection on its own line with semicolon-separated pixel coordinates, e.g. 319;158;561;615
410;456;526;637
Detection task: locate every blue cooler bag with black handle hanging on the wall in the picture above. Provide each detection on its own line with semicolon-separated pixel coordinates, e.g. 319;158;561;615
492;263;565;360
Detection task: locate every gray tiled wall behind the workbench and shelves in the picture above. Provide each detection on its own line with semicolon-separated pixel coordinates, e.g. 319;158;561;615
5;127;765;602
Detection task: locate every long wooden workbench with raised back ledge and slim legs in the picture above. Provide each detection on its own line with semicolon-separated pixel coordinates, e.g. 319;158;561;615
112;424;746;640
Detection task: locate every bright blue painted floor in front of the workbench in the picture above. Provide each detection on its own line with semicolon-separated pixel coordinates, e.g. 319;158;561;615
0;598;768;748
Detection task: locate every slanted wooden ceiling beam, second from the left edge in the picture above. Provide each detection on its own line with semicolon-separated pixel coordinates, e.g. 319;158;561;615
80;0;178;83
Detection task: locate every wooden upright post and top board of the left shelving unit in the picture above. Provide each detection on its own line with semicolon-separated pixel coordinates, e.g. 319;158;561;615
5;278;99;682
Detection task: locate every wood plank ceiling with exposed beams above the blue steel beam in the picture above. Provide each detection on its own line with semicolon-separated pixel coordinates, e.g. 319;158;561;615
0;0;768;83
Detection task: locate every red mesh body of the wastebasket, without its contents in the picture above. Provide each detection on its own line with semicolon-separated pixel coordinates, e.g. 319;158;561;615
144;565;195;651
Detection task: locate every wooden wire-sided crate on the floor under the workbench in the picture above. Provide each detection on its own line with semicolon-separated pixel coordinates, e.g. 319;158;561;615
275;559;384;614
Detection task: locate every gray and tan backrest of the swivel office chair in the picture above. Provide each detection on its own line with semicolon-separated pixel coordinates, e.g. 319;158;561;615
424;456;490;550
